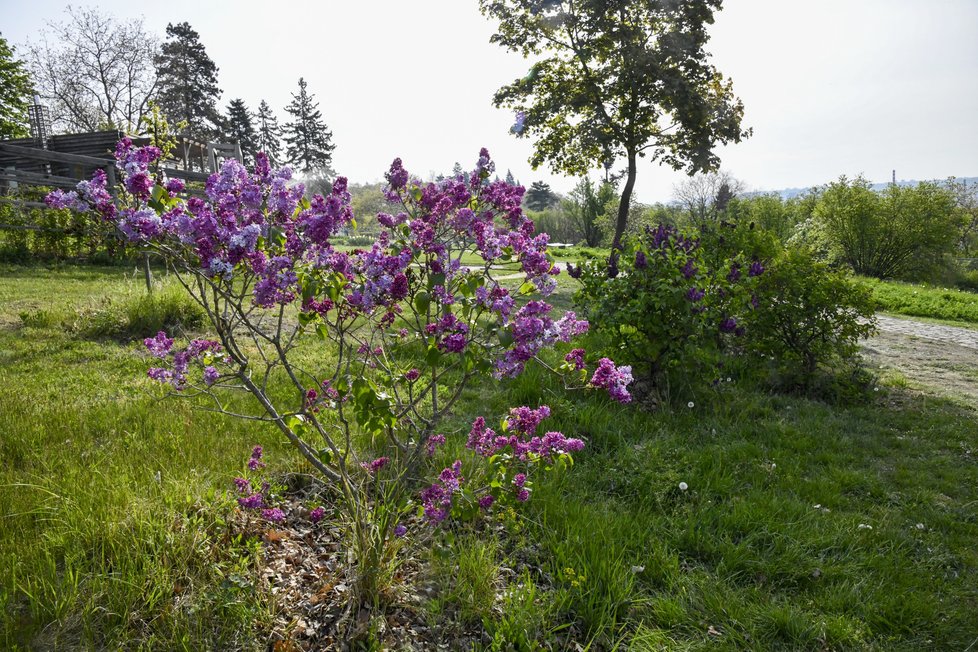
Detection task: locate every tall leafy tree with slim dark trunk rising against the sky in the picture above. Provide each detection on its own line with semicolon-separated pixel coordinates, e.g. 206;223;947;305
480;0;750;248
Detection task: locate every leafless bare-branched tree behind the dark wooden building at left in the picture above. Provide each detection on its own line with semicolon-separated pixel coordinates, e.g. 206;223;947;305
28;6;159;132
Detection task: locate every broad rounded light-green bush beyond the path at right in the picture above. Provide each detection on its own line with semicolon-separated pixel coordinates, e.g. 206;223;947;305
814;177;960;280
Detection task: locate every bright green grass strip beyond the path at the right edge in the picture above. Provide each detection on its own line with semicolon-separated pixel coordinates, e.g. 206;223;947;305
860;278;978;324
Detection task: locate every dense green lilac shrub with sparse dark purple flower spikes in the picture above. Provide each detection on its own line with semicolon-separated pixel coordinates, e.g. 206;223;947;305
569;225;764;400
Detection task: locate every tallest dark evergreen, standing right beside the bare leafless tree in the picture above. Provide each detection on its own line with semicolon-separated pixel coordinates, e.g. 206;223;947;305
156;23;224;145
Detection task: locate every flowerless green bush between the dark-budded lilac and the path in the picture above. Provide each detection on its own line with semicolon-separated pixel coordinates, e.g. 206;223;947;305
747;249;875;389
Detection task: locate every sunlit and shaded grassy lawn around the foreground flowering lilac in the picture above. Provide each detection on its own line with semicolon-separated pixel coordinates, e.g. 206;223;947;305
0;266;978;650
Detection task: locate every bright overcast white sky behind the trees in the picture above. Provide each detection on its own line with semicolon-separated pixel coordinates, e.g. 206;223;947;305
0;0;978;202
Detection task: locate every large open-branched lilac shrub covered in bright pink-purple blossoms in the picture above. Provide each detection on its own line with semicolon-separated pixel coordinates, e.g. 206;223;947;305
47;139;630;595
